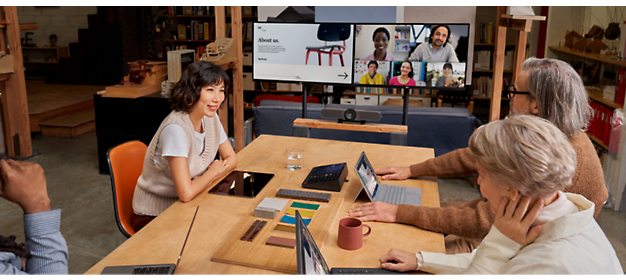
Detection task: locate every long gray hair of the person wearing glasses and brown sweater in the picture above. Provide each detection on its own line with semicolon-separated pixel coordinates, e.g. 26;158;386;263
522;57;591;136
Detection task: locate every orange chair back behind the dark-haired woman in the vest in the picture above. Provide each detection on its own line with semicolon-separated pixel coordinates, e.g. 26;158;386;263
107;140;148;237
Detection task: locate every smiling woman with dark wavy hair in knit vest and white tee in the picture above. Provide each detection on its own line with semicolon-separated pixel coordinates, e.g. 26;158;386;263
133;61;237;230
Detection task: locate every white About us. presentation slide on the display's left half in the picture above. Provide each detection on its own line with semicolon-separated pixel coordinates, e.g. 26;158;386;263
253;22;354;84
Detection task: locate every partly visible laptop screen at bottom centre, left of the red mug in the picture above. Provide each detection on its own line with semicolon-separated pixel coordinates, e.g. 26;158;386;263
296;210;330;275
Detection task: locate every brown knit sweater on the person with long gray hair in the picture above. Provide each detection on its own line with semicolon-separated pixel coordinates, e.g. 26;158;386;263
396;132;609;238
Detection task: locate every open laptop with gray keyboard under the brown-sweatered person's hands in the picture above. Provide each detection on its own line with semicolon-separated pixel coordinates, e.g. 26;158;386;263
354;152;422;206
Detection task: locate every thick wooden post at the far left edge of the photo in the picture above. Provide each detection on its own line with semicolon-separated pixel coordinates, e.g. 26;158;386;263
0;6;33;157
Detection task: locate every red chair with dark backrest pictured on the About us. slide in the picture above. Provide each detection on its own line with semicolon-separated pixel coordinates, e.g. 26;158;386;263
304;24;351;67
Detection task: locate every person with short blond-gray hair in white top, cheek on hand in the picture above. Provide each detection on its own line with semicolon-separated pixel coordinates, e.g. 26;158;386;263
380;115;624;275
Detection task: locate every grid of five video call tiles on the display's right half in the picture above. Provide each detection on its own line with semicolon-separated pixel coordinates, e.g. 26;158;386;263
353;24;469;90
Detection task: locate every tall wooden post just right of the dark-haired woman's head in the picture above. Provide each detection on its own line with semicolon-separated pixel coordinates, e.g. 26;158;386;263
230;6;244;152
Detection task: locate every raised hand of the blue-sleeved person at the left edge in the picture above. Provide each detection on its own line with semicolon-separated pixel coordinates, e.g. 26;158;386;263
0;159;50;214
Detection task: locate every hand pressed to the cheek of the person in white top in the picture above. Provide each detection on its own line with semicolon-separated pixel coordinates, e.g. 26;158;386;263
493;196;543;246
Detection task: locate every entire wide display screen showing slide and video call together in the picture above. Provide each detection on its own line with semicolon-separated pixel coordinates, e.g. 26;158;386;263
253;23;469;90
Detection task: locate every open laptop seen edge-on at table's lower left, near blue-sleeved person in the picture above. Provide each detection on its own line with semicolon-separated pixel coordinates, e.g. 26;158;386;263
100;205;200;275
